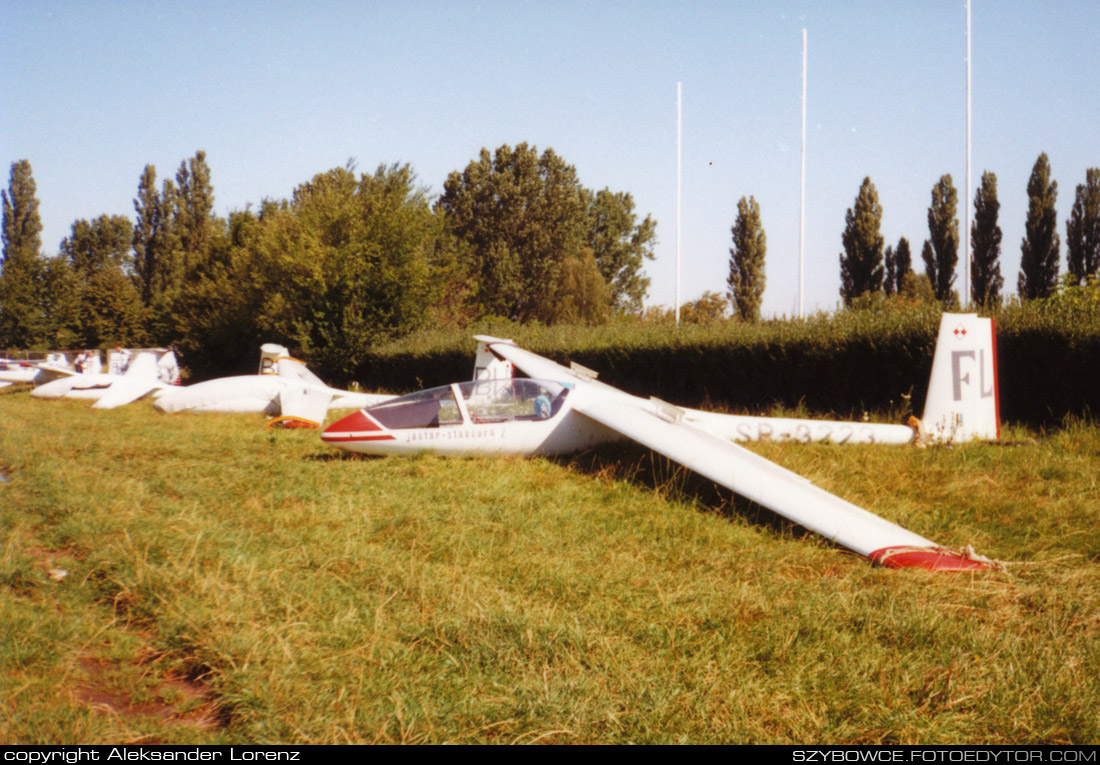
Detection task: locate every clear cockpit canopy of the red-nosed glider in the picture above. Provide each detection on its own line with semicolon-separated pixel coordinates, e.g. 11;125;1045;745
366;378;571;430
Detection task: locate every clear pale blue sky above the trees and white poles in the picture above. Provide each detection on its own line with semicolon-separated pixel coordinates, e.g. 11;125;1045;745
0;0;1100;314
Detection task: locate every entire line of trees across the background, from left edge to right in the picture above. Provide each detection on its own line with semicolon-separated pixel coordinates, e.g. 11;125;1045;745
0;143;1100;373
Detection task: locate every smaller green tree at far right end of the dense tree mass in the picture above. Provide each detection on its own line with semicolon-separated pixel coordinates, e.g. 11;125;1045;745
587;188;657;314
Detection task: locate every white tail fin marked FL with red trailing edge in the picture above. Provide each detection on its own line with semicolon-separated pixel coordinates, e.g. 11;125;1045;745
921;314;1001;442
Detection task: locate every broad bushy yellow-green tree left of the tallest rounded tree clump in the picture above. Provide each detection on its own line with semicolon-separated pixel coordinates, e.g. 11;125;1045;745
174;164;443;380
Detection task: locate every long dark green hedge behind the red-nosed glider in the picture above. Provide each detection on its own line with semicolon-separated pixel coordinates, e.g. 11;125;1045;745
356;302;1100;426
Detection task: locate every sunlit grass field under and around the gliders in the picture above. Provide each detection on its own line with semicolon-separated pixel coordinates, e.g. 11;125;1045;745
0;390;1100;743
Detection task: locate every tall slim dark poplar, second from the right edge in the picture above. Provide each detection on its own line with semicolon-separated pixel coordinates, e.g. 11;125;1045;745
1016;153;1062;300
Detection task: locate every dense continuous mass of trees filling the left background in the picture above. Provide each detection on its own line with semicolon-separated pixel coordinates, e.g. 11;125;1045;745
0;143;657;372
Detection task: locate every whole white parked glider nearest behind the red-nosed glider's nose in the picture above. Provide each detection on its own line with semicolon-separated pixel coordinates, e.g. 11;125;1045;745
153;343;394;427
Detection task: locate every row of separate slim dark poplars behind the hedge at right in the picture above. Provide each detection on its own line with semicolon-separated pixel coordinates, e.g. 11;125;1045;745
686;154;1100;321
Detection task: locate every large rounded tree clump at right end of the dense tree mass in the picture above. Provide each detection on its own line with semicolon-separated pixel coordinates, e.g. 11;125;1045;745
436;143;657;321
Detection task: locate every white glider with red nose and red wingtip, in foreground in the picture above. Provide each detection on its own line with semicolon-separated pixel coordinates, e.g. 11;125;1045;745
321;315;997;570
